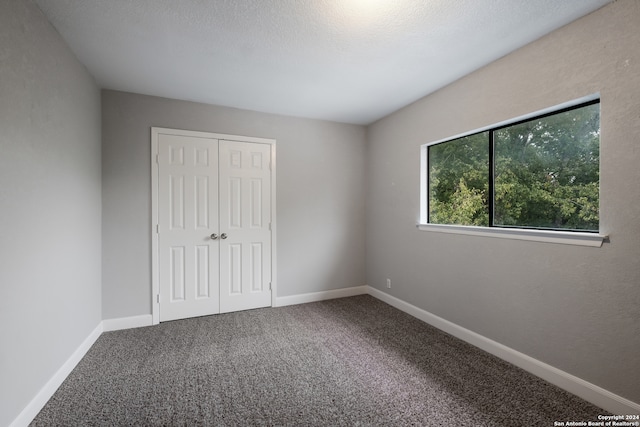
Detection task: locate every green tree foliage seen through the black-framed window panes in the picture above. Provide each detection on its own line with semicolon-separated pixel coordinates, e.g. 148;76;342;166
426;100;600;232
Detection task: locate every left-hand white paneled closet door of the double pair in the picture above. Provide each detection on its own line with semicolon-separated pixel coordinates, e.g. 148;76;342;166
157;134;220;321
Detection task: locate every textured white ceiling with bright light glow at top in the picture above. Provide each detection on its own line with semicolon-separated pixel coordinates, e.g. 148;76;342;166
35;0;611;124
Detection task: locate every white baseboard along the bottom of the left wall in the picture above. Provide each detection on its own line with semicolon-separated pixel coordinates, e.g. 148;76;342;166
10;322;102;427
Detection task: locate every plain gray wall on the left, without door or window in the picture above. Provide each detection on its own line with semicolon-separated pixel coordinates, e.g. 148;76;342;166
0;0;101;426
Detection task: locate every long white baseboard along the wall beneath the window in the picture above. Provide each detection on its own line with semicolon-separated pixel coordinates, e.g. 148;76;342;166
366;286;640;415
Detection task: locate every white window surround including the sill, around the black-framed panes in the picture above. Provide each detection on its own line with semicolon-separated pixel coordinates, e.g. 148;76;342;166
417;93;608;247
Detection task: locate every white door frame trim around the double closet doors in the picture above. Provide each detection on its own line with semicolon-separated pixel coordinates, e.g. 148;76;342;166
151;127;278;325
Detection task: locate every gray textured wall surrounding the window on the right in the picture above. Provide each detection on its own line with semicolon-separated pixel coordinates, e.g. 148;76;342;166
366;0;640;402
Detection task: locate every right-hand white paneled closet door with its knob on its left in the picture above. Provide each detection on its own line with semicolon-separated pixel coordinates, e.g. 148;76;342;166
219;140;271;313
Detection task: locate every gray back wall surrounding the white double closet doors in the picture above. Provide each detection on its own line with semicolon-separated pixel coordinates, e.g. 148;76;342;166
102;90;366;319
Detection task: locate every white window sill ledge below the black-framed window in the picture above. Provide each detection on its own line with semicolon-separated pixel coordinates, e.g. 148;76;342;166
418;224;607;248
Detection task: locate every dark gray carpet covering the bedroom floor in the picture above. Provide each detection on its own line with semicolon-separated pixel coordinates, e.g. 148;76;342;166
31;295;606;426
